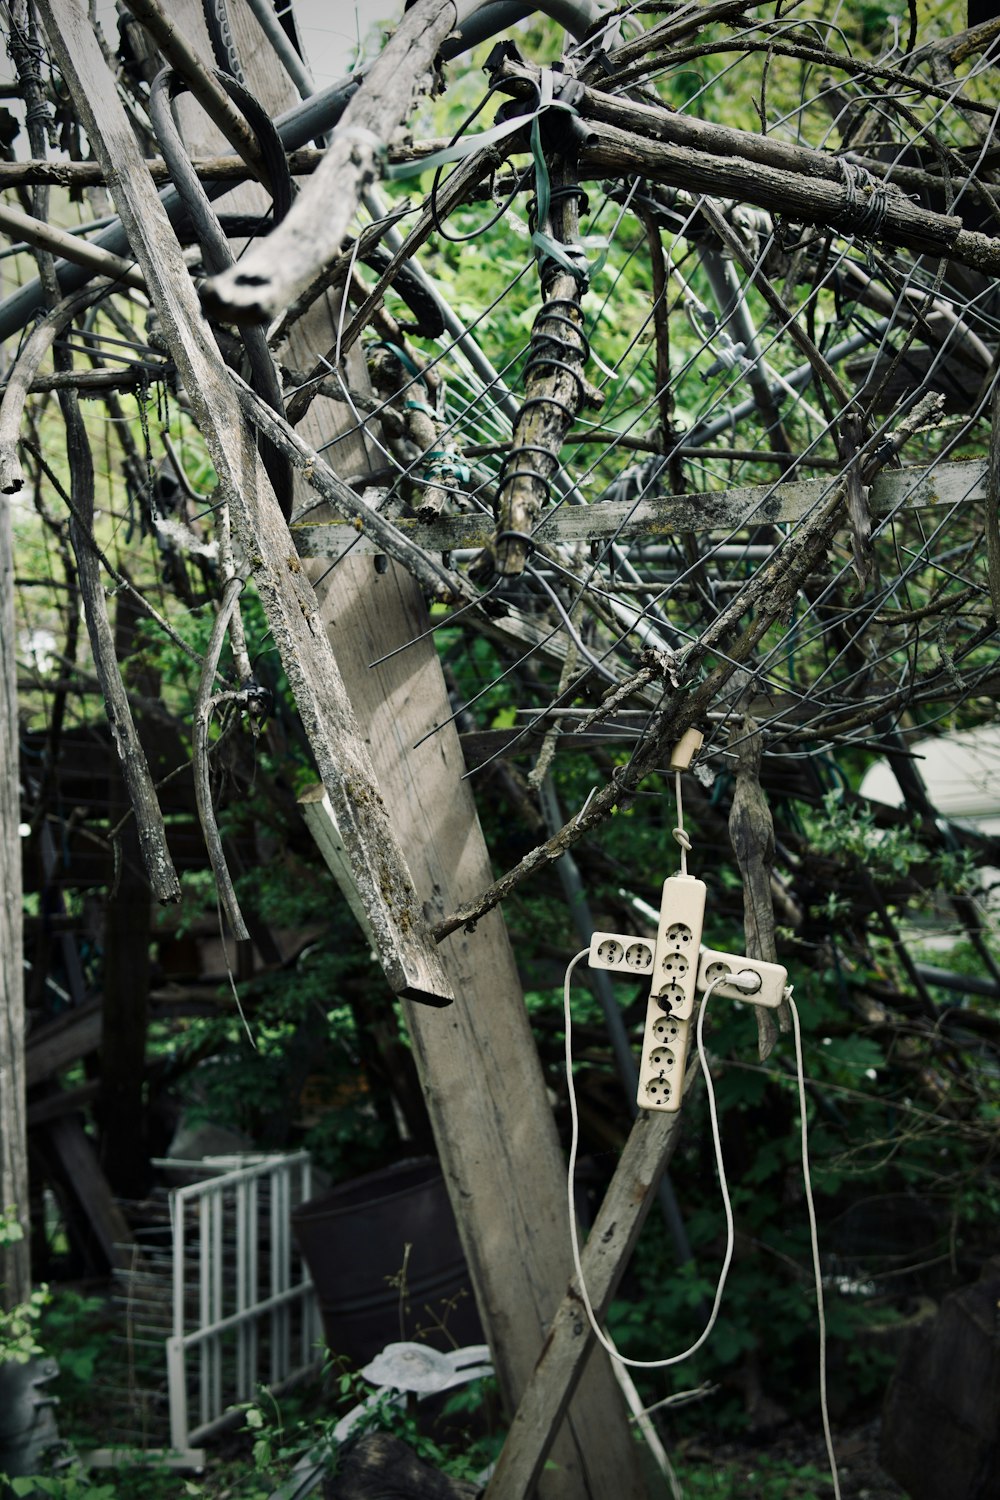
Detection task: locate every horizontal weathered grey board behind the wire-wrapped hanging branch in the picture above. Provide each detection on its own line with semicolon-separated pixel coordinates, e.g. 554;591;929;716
292;459;987;558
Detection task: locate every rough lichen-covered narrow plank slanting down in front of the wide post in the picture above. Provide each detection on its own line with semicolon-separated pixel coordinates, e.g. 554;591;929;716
40;0;453;1005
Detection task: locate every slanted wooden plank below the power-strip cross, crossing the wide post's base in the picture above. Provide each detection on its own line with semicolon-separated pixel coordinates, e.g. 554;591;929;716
486;1098;690;1500
